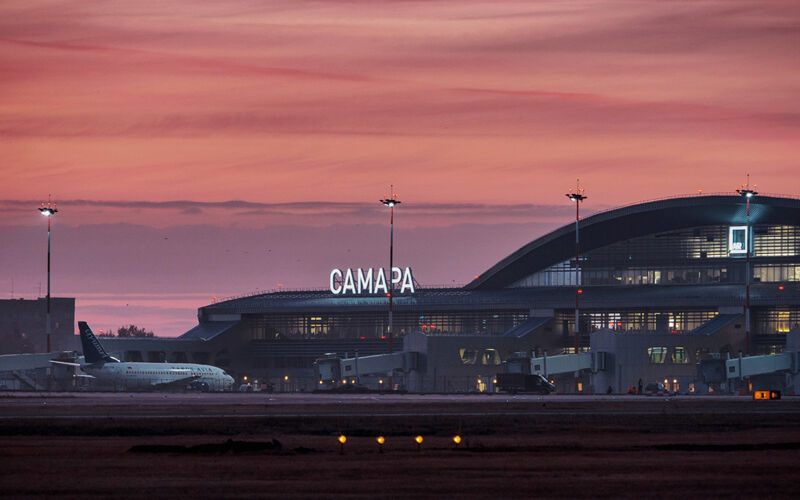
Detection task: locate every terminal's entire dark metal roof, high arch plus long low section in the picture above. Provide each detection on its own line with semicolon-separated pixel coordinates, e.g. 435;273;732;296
195;195;800;318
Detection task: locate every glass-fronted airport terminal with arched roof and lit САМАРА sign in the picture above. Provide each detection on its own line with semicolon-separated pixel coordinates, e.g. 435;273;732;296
104;195;800;391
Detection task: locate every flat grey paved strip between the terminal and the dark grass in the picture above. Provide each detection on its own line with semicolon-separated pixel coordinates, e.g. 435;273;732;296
0;393;800;421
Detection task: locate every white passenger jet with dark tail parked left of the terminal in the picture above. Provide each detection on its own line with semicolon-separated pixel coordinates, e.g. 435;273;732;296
50;321;234;391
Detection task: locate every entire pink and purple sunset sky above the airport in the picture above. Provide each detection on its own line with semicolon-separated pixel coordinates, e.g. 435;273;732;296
0;0;800;336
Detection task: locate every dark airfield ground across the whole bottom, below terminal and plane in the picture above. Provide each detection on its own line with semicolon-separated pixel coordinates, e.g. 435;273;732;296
0;394;800;499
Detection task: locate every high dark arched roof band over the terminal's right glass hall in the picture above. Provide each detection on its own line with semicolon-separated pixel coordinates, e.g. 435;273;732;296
465;195;800;290
